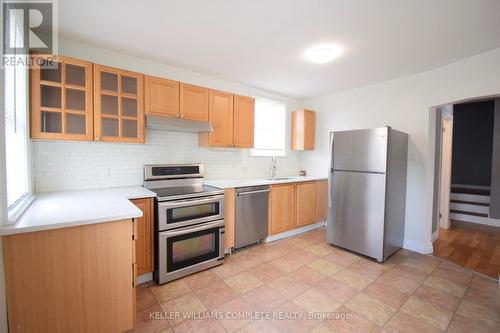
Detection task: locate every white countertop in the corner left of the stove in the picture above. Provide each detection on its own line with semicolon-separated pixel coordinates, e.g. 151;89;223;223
0;186;156;236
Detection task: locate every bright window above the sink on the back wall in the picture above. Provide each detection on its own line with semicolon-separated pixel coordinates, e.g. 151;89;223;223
252;97;286;156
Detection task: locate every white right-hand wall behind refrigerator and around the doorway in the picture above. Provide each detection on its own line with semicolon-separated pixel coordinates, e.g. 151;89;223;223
303;48;500;252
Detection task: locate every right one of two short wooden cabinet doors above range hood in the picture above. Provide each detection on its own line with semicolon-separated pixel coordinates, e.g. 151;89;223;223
180;83;208;121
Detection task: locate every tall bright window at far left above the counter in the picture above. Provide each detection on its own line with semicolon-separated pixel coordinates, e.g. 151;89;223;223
4;11;32;222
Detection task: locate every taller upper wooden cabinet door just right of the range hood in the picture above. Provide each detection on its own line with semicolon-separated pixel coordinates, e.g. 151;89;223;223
208;90;233;147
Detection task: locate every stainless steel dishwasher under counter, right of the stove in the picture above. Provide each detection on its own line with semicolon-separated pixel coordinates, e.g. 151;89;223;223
234;186;269;249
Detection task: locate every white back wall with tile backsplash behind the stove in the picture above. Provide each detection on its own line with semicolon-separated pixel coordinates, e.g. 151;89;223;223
33;40;302;192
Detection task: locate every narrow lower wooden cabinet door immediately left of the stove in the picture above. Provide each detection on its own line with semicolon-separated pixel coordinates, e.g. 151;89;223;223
131;198;154;275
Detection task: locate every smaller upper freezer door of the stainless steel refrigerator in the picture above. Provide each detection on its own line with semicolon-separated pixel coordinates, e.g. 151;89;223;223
332;127;389;172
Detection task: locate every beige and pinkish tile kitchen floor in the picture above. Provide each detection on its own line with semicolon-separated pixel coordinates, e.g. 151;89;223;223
133;229;500;333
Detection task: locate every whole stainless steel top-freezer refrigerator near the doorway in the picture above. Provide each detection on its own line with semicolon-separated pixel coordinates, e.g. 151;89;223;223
327;127;408;262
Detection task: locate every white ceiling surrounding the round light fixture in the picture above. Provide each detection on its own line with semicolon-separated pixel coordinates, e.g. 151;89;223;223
59;0;500;98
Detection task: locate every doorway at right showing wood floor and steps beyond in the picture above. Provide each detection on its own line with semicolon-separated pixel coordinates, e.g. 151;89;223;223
432;99;500;279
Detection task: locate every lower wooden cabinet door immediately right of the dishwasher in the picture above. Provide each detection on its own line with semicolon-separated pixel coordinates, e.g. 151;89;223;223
268;184;295;235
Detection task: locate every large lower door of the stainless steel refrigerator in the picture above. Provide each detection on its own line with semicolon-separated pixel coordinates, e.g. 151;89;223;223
327;171;385;261
